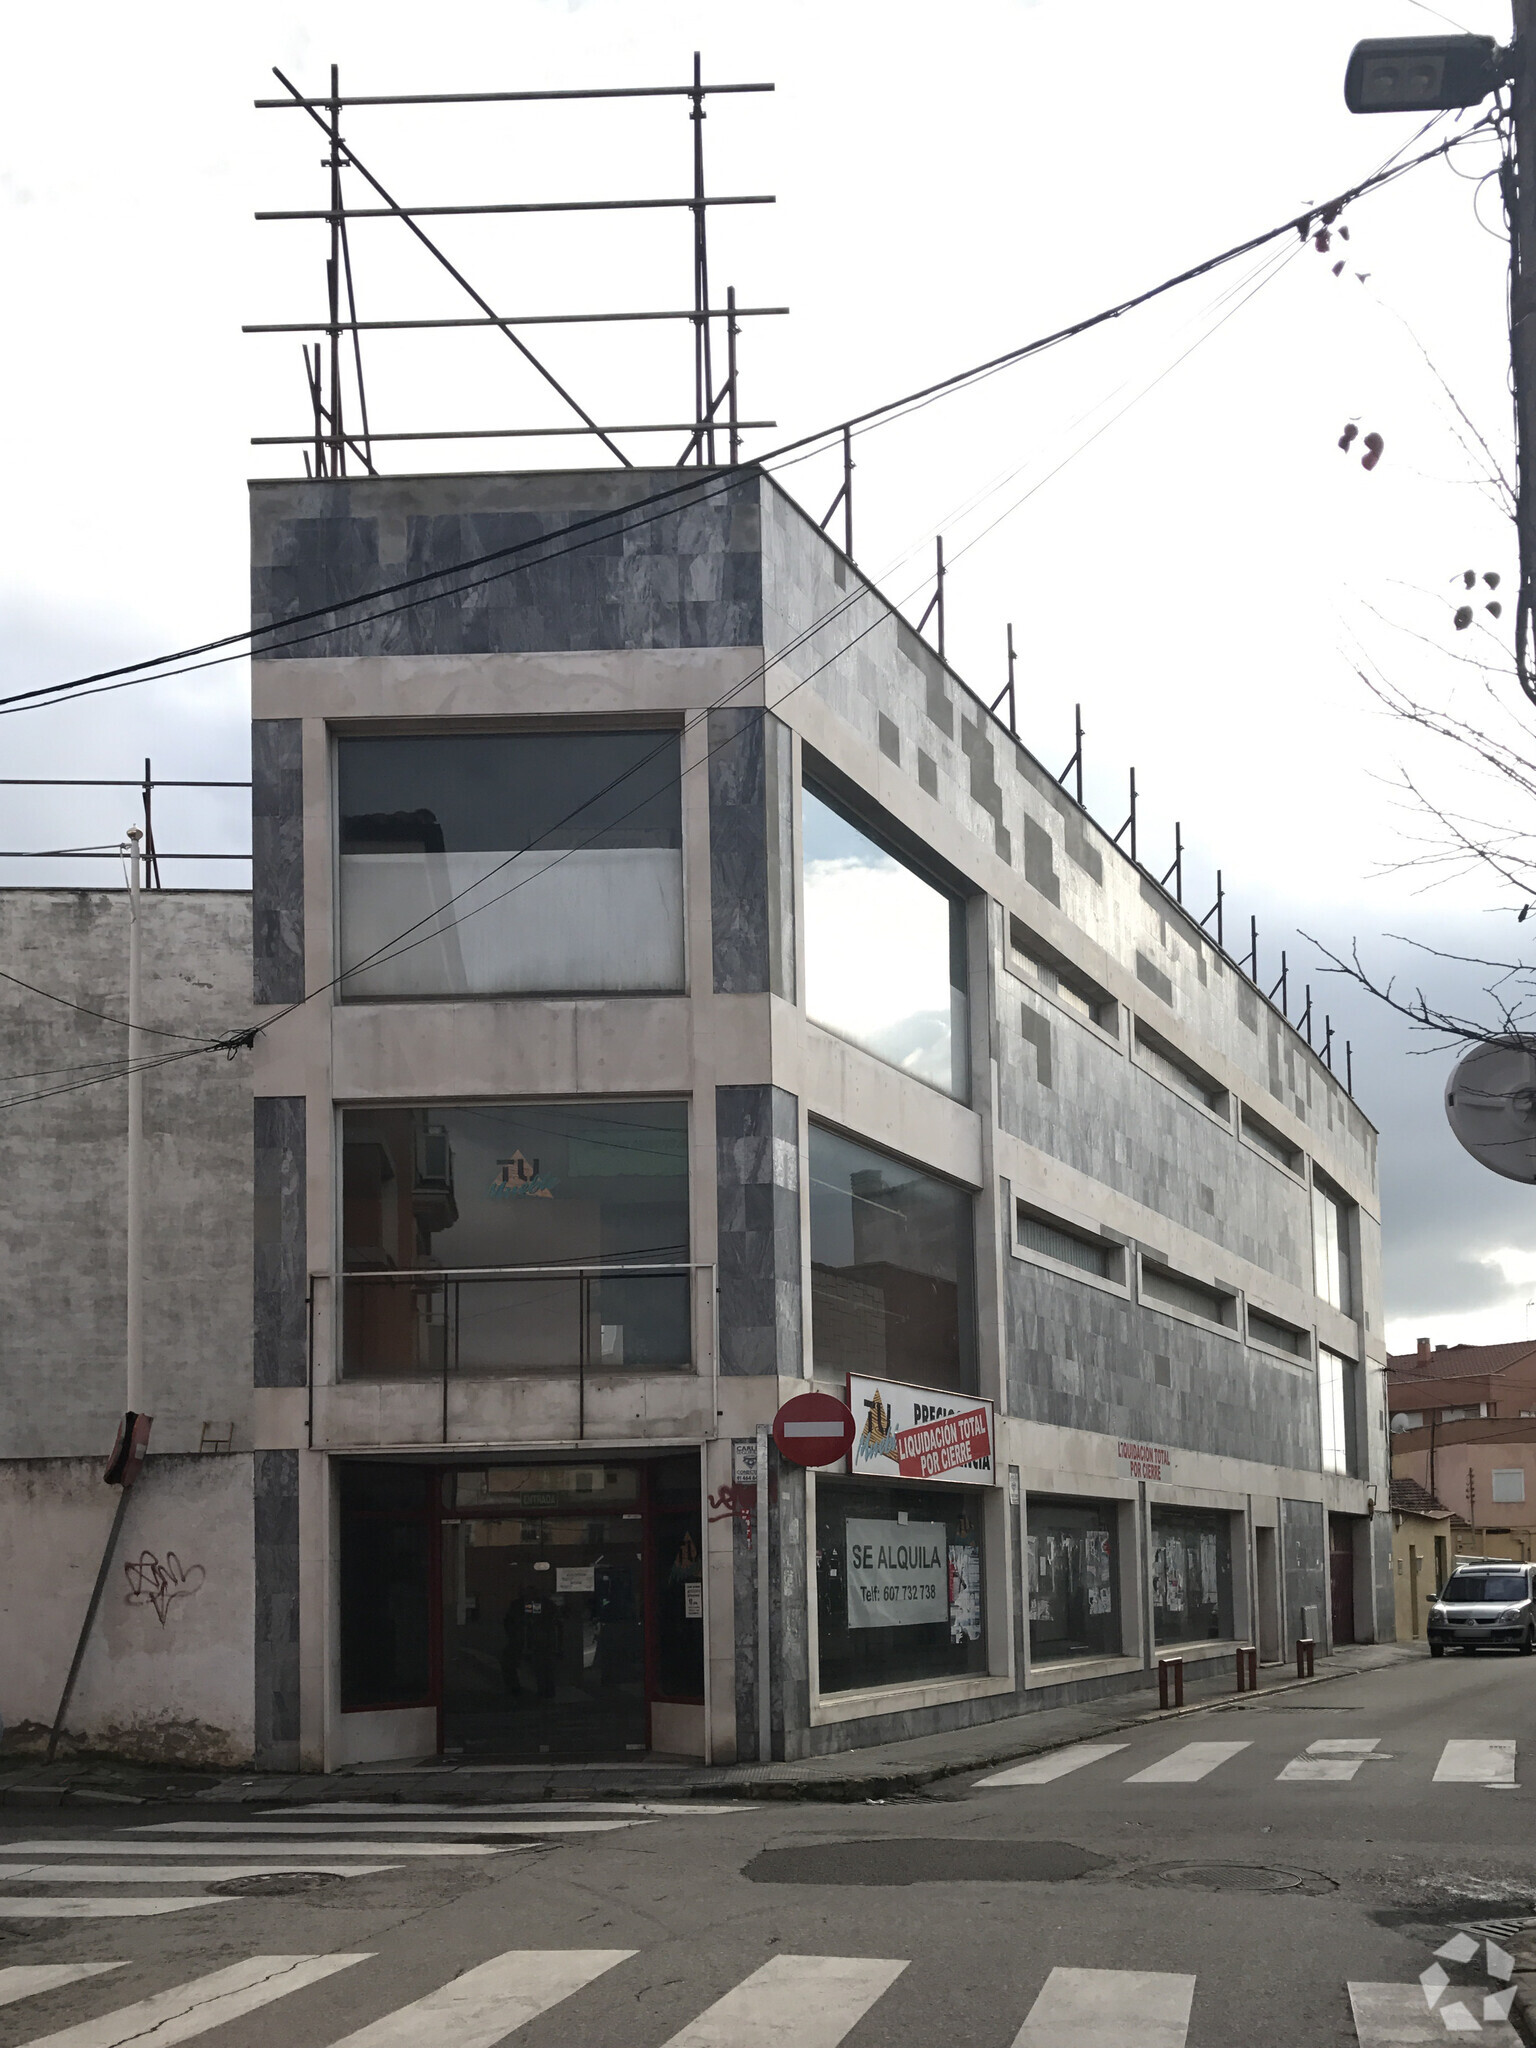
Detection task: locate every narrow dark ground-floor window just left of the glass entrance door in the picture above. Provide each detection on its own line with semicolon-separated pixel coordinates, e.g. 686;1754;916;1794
336;1464;434;1710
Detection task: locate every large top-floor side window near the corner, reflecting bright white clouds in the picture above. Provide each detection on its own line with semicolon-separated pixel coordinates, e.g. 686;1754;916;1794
803;784;969;1100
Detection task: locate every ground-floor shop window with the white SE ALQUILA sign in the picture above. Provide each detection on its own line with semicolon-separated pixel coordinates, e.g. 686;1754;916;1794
815;1479;987;1694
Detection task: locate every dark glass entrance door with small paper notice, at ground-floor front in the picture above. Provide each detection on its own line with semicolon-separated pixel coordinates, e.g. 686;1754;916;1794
442;1509;645;1761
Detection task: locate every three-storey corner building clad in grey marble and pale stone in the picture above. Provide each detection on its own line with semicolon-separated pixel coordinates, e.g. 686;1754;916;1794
0;469;1395;1767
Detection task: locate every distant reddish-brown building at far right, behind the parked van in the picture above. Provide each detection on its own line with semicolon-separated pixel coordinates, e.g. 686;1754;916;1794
1386;1337;1536;1559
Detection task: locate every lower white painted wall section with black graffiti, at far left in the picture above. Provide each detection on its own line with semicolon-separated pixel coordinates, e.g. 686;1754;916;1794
0;1454;256;1767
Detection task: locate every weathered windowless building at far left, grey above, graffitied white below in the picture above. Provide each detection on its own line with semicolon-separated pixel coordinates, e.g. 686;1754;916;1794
0;889;256;1765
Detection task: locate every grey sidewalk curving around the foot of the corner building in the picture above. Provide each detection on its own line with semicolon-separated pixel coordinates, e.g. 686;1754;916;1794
0;1642;1423;1810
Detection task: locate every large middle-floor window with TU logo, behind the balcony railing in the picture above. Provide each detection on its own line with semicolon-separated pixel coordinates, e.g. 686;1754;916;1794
342;1102;690;1378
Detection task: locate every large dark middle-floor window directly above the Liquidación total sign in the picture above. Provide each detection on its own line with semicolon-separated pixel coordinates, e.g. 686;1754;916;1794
811;1124;977;1393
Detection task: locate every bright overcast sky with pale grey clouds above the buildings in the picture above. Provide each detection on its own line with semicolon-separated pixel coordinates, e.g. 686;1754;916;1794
0;0;1536;1348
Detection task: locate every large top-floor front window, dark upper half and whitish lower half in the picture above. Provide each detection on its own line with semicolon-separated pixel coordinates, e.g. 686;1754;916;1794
336;731;682;1001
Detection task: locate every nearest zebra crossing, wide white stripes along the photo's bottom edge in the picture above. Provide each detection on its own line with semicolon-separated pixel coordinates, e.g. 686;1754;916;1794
0;1948;1520;2048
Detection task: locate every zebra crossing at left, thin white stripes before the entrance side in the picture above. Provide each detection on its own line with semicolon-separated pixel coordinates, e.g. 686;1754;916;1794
0;1800;750;1921
